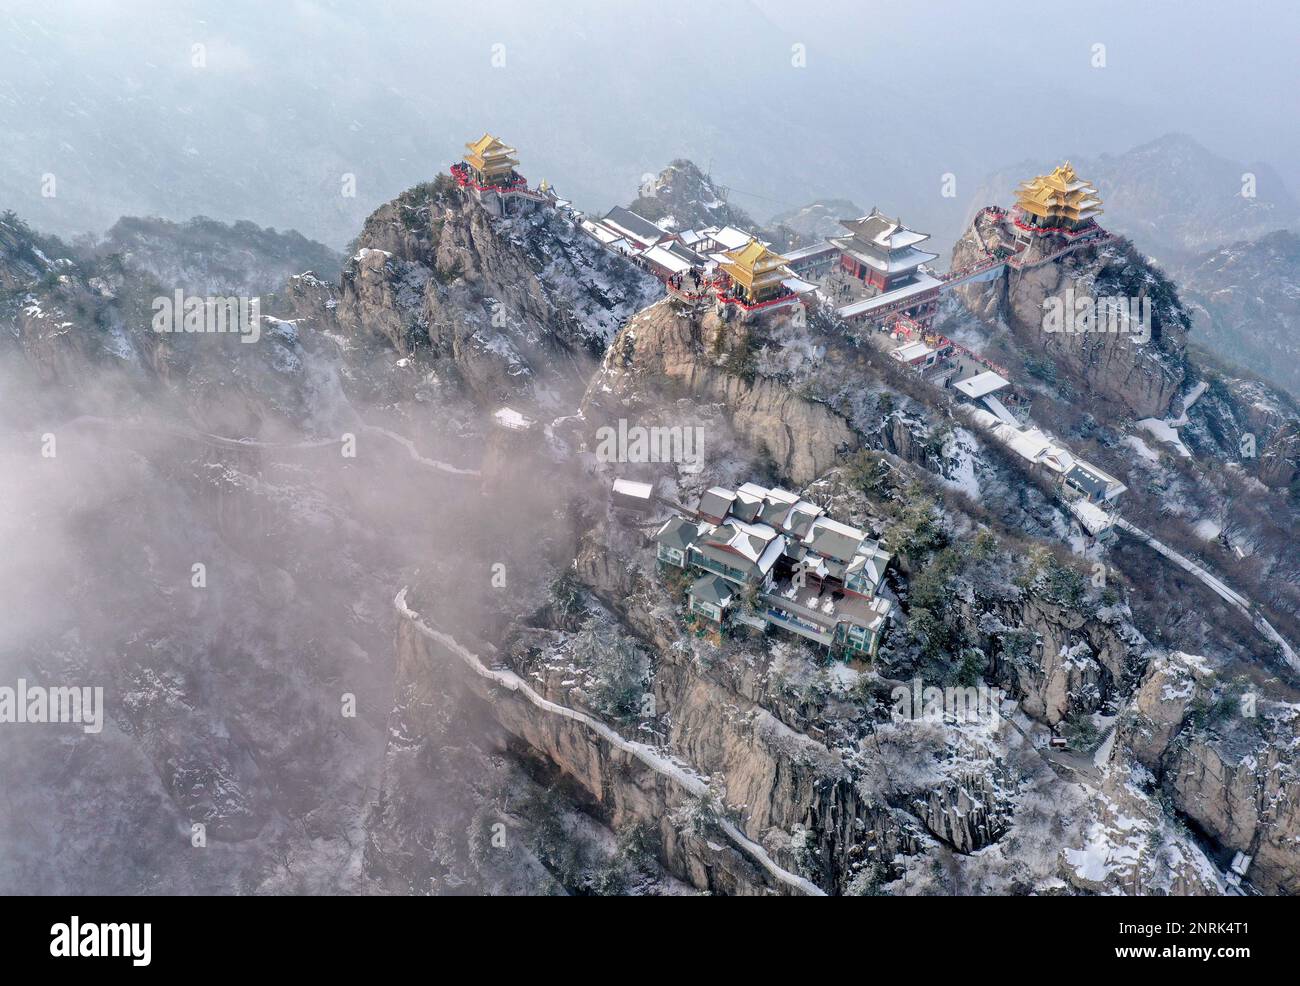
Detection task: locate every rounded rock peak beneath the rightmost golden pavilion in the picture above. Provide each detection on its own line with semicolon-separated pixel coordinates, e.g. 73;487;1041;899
953;215;1191;418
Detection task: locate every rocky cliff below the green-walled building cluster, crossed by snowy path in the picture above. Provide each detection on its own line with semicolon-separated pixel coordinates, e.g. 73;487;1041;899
399;564;1056;894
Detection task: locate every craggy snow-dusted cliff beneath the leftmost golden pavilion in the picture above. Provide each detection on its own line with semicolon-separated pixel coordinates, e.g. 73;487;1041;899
319;177;662;410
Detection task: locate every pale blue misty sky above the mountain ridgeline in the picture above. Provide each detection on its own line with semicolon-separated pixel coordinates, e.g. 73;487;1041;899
0;0;1300;247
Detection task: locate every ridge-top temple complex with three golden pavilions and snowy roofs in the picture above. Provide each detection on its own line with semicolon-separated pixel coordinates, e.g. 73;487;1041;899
451;134;1108;340
